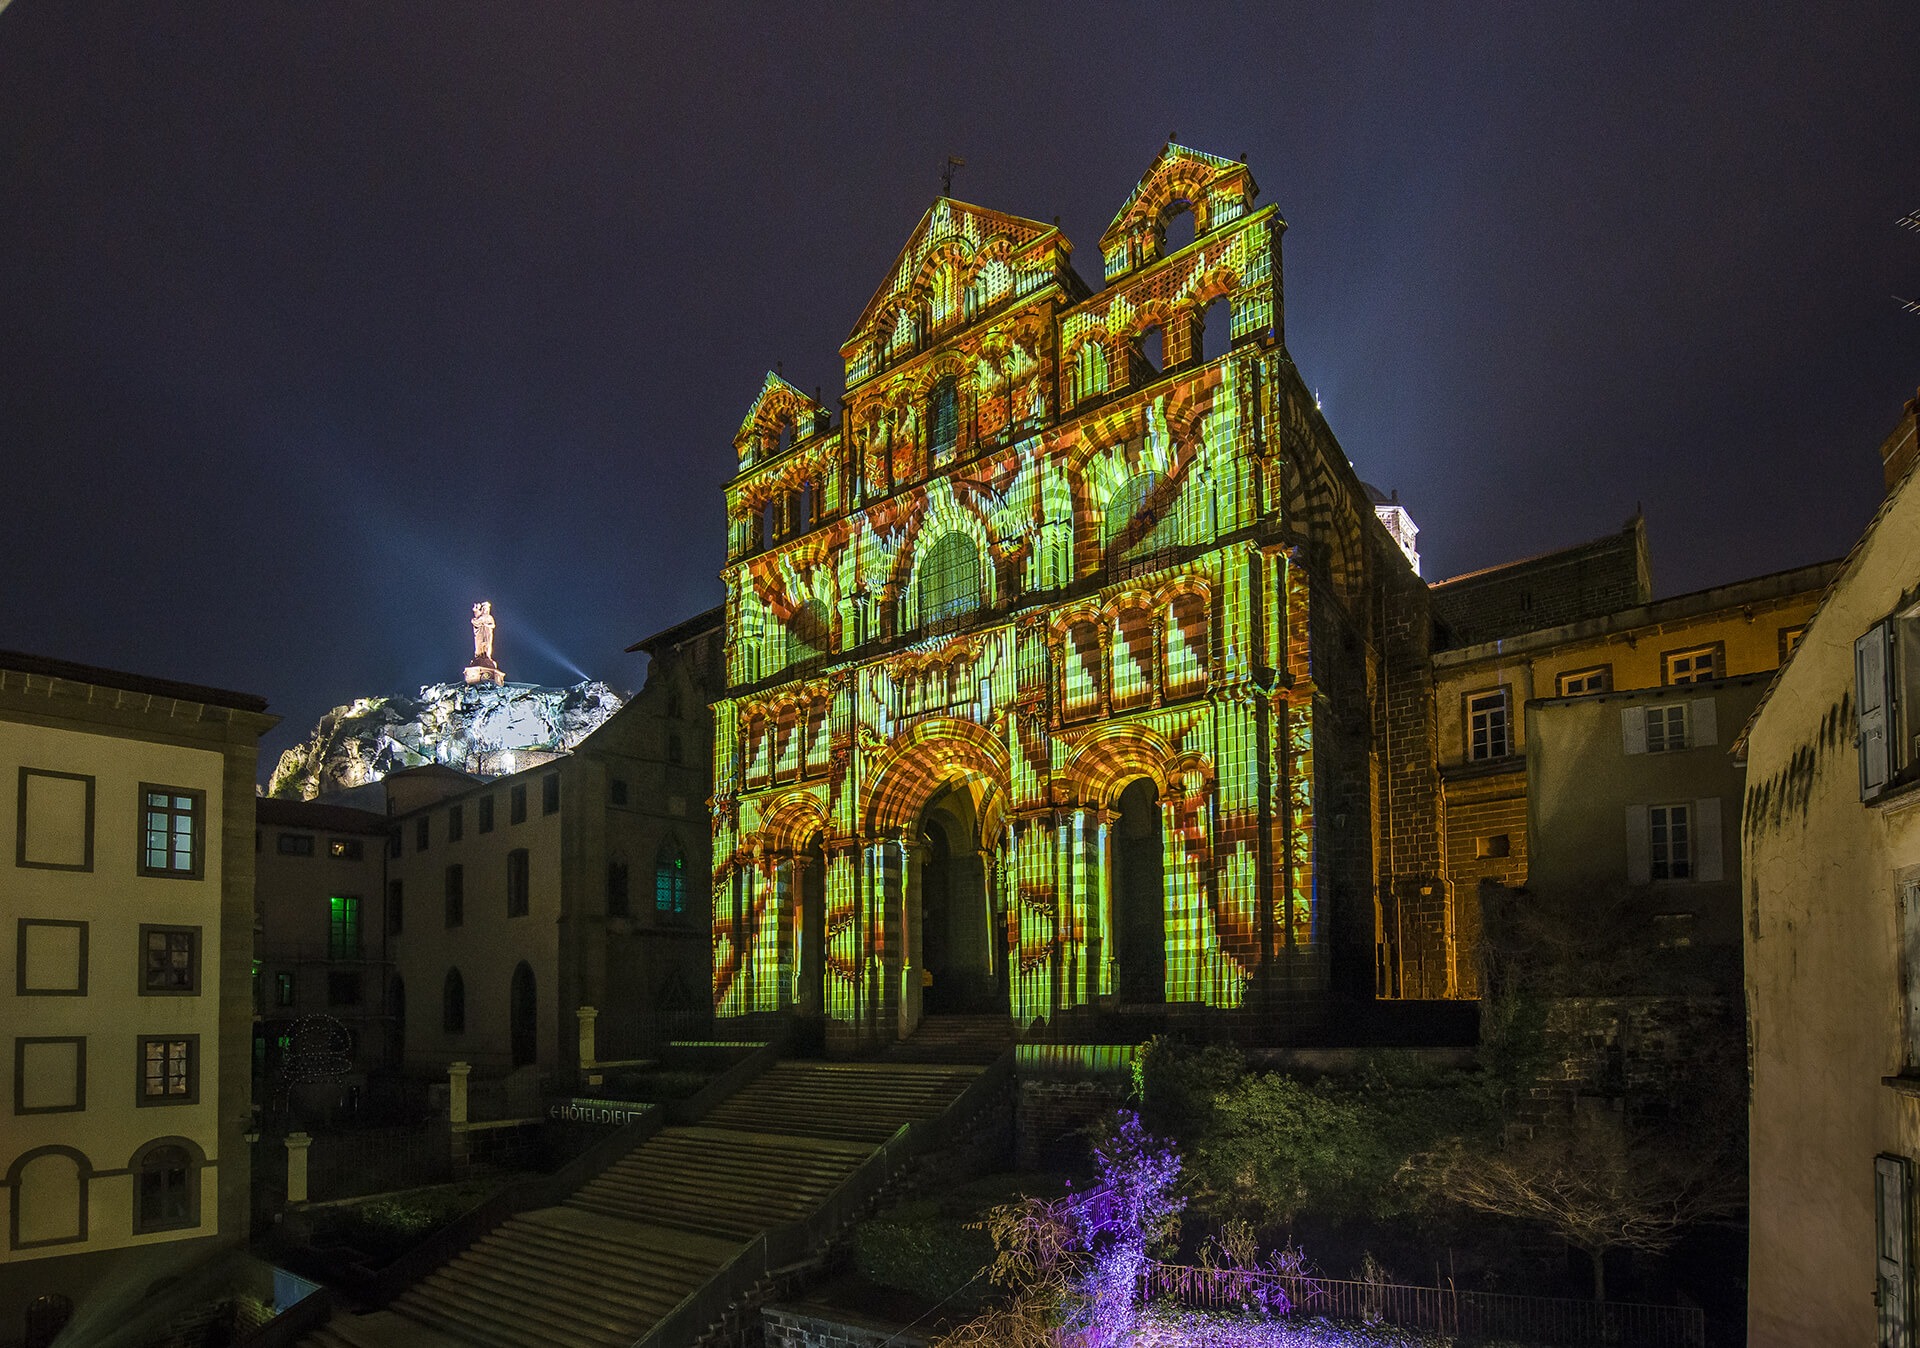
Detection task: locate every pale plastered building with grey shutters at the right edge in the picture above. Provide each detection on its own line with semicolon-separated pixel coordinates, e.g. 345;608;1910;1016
1740;385;1920;1348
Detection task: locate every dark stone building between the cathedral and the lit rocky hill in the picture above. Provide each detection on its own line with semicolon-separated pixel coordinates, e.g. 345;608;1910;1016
384;613;720;1085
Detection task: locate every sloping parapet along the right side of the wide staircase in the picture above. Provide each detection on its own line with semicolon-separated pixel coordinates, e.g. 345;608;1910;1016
630;1048;1014;1348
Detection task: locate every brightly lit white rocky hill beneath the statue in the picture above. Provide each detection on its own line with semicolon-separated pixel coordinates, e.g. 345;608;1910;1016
267;680;626;801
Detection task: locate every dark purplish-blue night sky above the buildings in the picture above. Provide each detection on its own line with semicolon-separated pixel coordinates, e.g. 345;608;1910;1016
0;0;1920;772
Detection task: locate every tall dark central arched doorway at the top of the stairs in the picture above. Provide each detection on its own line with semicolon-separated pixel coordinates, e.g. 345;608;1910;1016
914;782;1008;1014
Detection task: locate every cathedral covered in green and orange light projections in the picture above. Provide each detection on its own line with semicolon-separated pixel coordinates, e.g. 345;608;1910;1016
712;144;1465;1045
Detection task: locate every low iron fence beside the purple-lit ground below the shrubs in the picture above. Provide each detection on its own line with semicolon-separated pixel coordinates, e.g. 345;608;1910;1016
1146;1264;1707;1348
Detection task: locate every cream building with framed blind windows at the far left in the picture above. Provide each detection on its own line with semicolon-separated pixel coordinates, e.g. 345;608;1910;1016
0;653;275;1344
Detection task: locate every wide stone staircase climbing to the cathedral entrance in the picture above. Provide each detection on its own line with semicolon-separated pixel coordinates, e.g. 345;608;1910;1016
300;1062;981;1348
